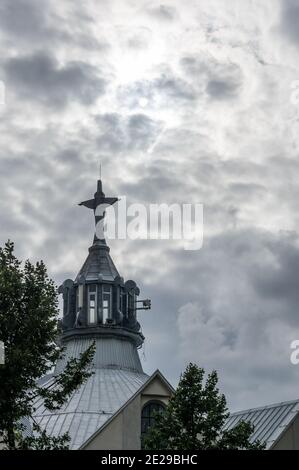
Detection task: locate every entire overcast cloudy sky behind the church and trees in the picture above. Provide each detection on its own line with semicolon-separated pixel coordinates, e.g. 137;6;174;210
0;0;299;409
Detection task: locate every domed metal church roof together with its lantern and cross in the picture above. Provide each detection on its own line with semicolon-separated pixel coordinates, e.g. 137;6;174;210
33;176;155;449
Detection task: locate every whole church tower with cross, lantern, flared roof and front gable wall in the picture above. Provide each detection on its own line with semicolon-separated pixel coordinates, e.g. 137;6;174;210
34;180;173;450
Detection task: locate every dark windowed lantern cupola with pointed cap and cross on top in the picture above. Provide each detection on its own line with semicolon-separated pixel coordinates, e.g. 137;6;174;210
59;180;150;347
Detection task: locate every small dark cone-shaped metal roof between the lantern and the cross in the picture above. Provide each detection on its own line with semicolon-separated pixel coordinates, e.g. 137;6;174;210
76;243;119;281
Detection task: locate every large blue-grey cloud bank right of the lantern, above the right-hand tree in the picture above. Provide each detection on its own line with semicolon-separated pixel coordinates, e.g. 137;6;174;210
125;228;299;409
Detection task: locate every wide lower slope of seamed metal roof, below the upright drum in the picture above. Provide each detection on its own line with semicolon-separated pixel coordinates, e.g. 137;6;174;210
33;368;148;449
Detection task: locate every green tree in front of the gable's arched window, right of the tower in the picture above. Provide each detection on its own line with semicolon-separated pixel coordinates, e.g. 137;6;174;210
143;363;264;450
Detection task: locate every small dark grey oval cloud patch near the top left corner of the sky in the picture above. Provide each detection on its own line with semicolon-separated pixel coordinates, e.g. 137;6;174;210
3;52;106;107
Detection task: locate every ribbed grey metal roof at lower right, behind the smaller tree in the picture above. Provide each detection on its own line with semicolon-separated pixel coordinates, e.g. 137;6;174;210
224;400;299;449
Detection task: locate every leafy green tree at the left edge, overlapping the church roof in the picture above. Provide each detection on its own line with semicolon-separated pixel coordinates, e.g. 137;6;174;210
0;241;94;449
